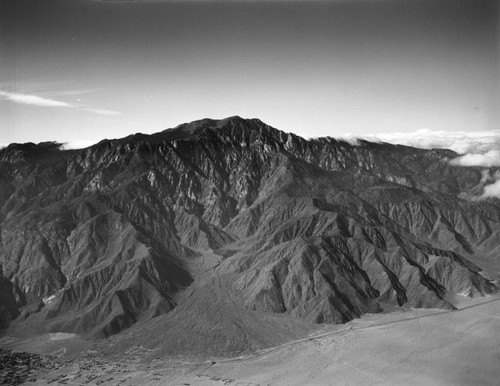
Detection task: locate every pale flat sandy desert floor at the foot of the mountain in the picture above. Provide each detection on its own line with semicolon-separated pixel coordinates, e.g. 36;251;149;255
0;298;500;386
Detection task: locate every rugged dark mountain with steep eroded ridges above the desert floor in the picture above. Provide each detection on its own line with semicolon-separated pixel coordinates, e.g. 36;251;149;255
0;117;500;354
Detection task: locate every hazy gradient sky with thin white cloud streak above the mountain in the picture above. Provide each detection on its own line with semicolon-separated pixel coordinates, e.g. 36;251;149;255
0;0;500;144
